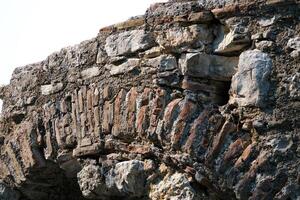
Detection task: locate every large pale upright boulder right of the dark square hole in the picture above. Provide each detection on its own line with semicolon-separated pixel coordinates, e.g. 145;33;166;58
230;50;272;107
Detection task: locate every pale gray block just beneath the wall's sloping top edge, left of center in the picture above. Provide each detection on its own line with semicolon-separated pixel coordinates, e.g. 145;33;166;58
105;30;155;57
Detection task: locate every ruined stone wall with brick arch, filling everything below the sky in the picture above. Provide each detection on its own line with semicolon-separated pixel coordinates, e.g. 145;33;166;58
0;0;300;200
